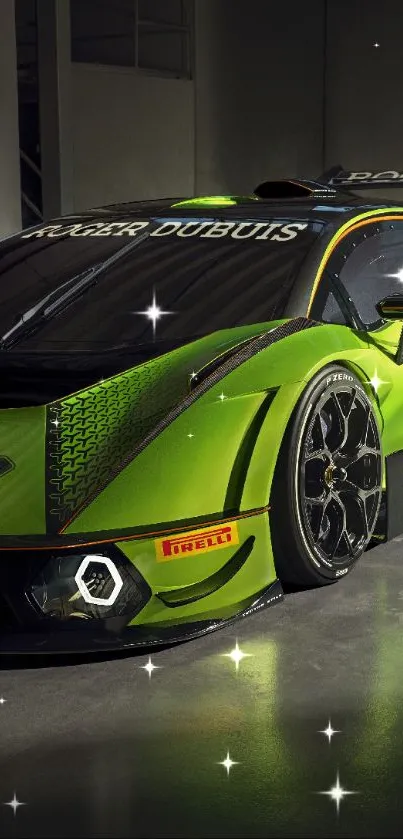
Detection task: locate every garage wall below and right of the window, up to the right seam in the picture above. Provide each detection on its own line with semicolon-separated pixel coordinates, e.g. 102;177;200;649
72;0;324;209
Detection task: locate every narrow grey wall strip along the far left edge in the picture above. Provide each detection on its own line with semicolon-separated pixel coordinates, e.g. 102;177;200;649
0;0;21;238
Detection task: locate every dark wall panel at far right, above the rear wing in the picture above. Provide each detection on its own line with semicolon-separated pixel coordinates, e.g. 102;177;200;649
326;0;403;199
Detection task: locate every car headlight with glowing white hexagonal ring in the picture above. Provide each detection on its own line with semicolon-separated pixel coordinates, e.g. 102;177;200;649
27;549;151;620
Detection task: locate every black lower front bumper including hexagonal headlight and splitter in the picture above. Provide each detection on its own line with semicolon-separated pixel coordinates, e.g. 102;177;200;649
0;545;283;655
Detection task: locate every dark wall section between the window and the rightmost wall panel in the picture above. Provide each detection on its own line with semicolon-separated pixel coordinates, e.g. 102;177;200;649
195;0;325;193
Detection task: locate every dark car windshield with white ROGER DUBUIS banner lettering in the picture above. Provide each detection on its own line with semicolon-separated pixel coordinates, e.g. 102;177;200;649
0;217;321;353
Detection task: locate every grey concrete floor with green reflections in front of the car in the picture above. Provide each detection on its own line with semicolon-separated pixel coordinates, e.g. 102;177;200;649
0;541;403;839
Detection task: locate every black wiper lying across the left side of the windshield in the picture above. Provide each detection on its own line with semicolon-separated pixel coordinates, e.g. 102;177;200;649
0;225;153;350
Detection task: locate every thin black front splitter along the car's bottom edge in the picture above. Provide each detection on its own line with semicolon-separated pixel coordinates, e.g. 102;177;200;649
0;580;284;655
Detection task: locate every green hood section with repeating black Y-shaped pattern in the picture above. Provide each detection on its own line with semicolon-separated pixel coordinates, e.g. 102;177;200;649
46;351;189;533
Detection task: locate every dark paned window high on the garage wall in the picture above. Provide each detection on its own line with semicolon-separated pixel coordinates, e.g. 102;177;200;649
70;0;192;78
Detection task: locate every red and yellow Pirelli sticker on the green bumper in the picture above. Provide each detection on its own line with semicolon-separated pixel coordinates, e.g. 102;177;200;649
155;522;239;562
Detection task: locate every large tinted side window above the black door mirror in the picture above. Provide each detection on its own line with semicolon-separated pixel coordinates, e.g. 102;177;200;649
338;222;403;327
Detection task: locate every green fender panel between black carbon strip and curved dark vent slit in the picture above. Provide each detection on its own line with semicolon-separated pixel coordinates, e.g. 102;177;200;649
65;387;265;533
